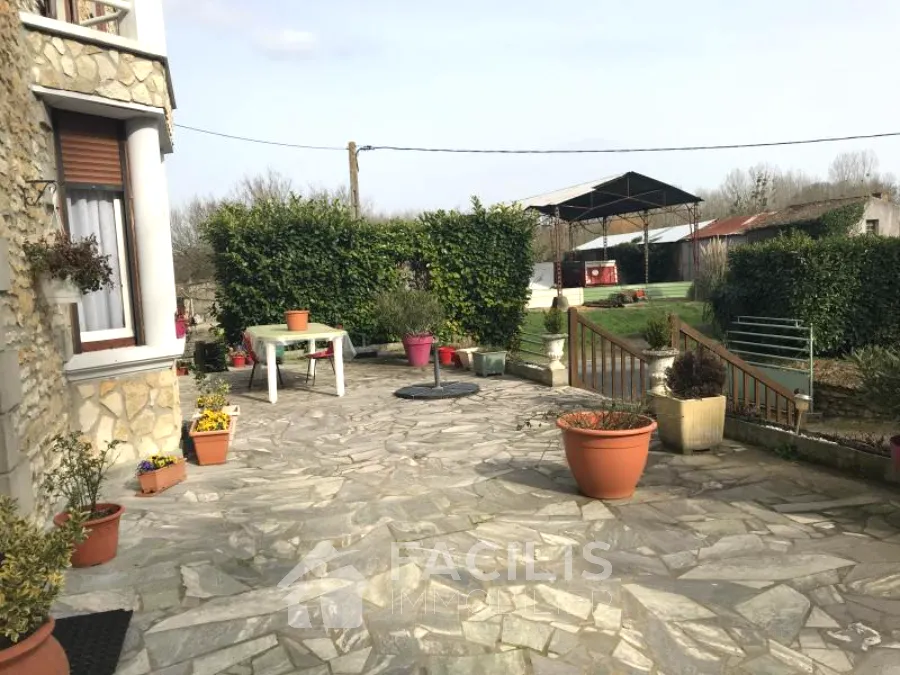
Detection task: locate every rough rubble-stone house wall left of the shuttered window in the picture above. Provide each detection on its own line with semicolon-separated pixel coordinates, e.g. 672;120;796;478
0;0;71;512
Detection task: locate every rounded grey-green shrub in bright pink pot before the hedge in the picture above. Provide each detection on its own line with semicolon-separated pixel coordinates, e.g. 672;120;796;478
375;286;444;367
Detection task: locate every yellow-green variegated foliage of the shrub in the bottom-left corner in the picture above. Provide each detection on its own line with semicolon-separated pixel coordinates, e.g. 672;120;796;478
0;496;84;650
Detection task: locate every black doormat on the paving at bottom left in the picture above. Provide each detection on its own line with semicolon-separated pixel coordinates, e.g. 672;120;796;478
53;609;132;675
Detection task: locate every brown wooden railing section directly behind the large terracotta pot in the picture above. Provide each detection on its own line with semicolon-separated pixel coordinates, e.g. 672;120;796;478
568;307;647;401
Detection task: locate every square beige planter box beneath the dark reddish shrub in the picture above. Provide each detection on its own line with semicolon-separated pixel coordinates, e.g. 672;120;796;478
653;396;725;454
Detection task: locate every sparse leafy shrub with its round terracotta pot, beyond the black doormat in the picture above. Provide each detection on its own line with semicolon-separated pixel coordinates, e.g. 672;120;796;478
43;433;125;567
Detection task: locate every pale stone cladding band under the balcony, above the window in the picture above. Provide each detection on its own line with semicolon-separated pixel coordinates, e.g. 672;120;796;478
27;29;172;122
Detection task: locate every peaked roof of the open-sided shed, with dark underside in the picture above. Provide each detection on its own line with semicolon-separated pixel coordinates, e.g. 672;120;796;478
519;171;703;223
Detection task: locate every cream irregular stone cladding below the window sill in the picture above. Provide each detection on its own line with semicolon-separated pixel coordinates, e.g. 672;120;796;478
72;368;181;462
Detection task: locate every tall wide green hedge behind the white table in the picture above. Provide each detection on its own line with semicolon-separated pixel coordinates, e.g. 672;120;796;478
204;197;535;346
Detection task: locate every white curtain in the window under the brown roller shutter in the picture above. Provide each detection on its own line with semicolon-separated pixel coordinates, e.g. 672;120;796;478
66;190;125;332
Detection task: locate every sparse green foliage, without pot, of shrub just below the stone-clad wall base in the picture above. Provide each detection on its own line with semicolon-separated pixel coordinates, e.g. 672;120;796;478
42;432;121;520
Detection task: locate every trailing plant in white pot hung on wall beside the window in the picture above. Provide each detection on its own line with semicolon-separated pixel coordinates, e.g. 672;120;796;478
24;232;113;304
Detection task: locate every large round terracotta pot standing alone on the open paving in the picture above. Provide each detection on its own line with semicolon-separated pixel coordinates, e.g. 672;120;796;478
556;412;656;499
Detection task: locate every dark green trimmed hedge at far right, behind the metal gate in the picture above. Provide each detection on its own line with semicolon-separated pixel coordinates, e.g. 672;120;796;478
710;234;900;355
